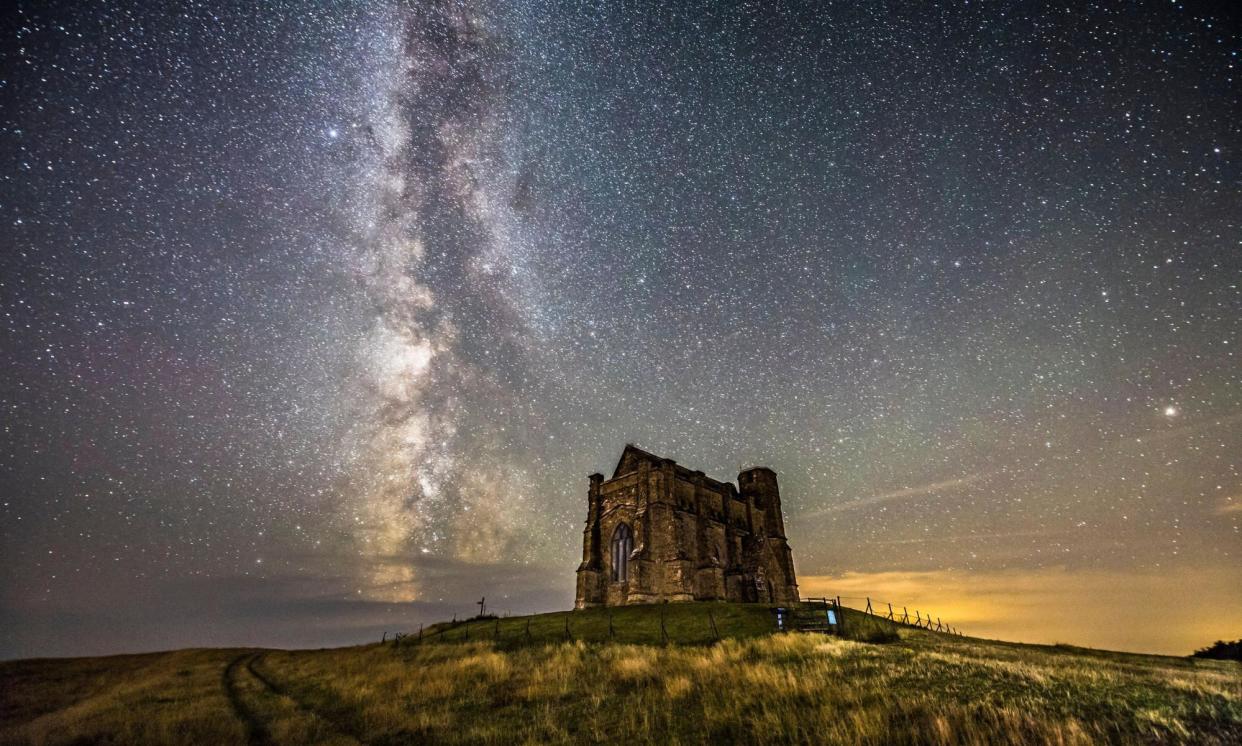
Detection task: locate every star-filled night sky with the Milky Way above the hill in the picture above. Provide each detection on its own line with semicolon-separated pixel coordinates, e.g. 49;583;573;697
0;1;1242;657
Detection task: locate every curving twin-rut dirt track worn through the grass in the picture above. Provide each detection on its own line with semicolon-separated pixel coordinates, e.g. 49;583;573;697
224;653;360;746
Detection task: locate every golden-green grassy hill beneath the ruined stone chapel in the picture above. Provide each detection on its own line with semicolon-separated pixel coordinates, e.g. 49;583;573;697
0;603;1242;744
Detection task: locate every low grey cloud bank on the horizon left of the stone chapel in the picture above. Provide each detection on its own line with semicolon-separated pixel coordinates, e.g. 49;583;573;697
0;557;573;659
